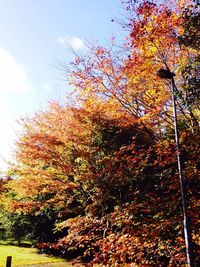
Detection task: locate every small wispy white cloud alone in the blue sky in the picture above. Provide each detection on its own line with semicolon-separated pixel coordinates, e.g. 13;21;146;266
57;36;84;50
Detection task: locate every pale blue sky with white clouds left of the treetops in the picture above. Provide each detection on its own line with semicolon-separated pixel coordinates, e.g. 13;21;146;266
0;0;123;170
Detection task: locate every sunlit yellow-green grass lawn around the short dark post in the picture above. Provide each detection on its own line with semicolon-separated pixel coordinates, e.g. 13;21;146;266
0;244;72;267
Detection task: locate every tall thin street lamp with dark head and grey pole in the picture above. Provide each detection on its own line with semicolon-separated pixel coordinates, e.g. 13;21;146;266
158;69;194;267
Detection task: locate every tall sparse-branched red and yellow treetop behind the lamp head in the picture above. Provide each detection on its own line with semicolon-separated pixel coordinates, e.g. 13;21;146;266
67;1;197;134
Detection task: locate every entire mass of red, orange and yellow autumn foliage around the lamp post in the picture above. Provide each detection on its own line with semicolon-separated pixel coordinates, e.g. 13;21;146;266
0;0;200;267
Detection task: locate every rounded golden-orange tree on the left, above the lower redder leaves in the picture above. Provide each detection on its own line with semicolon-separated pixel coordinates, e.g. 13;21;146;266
5;102;147;218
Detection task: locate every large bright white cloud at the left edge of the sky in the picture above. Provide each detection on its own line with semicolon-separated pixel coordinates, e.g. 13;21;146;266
0;47;32;93
